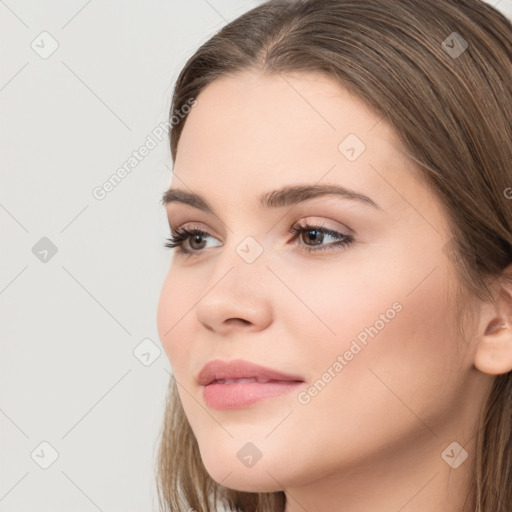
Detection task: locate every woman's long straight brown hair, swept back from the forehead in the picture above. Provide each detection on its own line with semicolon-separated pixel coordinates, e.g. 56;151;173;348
156;0;512;512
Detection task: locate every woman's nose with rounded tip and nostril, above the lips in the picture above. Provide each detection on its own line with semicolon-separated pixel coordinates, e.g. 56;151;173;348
196;252;273;335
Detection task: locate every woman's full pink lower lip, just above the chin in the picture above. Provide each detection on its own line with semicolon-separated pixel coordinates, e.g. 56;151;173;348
203;380;304;410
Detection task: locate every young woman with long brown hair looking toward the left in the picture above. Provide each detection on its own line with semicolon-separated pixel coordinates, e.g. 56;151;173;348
157;0;512;512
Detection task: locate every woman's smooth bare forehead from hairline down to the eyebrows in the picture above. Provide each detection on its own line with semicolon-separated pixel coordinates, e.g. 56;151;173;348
175;72;424;212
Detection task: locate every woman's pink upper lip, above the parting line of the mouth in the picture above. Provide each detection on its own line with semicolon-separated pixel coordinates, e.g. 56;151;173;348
197;359;304;386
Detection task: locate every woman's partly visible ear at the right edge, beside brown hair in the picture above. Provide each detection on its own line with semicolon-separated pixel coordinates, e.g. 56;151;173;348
474;265;512;375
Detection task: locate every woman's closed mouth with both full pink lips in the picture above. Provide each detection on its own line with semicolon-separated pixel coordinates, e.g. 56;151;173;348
197;359;304;410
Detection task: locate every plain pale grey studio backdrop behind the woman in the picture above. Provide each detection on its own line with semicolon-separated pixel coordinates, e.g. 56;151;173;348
0;0;512;512
